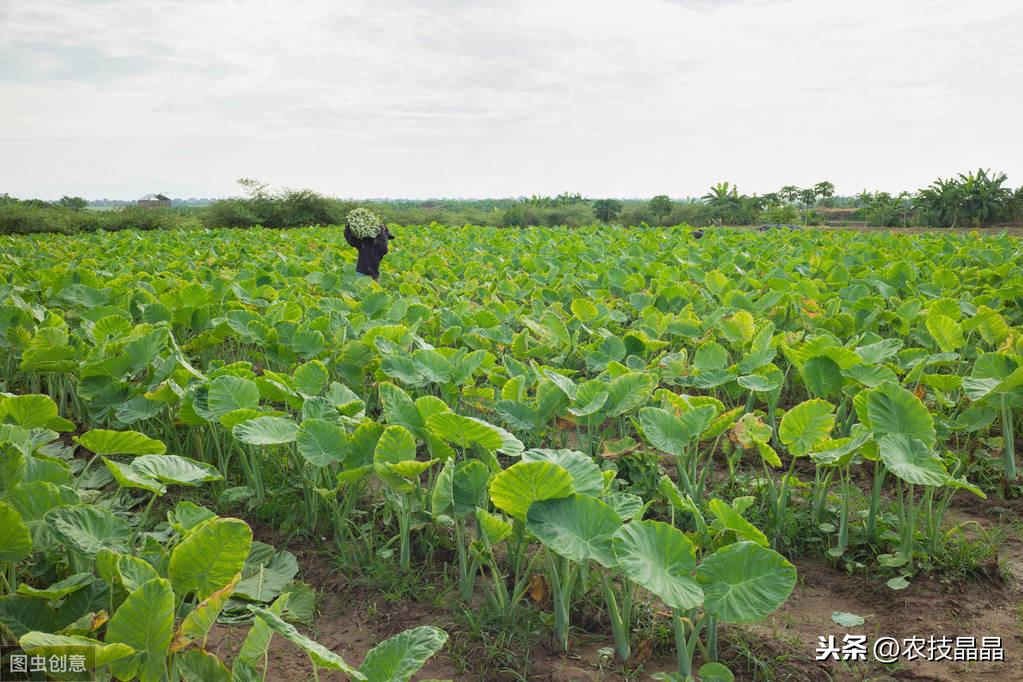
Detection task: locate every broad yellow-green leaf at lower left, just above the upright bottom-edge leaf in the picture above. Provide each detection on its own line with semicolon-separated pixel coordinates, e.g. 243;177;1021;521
168;517;253;599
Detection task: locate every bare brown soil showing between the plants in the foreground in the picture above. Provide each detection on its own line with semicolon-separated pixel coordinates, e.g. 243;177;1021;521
201;500;1023;682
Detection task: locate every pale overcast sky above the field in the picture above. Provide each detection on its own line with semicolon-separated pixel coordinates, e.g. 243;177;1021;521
0;0;1023;199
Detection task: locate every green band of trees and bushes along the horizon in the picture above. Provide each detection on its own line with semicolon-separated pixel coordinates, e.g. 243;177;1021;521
0;169;1023;234
